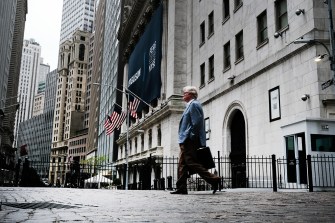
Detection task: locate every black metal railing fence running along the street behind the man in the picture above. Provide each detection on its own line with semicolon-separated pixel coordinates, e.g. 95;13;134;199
0;153;335;191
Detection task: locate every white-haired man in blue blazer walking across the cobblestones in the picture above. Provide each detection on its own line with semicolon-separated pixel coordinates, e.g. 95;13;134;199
171;86;220;194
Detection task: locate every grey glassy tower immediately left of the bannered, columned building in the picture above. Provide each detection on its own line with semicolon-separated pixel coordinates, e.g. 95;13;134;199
97;0;122;162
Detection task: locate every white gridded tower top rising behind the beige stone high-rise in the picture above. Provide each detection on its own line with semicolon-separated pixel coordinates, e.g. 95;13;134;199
60;0;95;44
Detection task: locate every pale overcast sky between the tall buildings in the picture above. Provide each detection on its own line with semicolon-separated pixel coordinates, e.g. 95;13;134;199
24;0;63;71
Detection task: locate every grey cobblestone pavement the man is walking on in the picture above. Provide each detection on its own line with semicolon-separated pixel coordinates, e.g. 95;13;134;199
0;187;335;223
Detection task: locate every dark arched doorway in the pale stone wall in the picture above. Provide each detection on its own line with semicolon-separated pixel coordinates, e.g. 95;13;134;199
230;110;247;188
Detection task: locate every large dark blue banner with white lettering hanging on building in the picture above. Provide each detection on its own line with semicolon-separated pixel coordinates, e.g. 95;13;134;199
128;5;163;111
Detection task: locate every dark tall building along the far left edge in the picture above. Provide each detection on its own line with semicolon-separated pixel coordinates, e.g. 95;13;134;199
0;0;28;174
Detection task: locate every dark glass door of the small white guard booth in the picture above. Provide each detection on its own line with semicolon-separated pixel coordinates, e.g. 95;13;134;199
285;133;307;184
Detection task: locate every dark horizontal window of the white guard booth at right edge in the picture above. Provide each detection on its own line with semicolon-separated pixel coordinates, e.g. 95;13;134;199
311;134;335;152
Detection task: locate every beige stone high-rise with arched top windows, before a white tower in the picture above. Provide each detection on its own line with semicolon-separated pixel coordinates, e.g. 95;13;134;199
50;30;91;186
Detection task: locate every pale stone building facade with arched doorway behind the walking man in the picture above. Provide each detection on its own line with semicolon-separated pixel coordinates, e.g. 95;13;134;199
116;0;335;187
